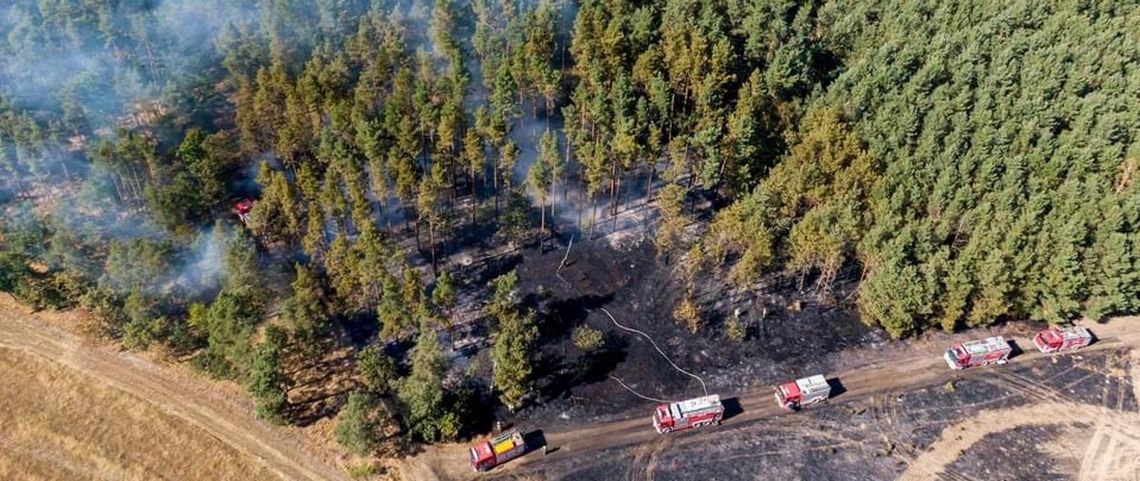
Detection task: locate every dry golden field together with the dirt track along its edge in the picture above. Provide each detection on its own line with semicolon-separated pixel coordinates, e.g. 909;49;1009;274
0;295;348;481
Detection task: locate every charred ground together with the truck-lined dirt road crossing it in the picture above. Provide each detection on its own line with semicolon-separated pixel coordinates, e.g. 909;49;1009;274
405;242;1140;481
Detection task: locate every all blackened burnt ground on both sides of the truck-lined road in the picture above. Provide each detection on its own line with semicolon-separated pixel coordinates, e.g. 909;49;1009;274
433;241;1138;480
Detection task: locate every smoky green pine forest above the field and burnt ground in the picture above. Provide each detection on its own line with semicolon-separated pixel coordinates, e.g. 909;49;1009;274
0;0;1140;462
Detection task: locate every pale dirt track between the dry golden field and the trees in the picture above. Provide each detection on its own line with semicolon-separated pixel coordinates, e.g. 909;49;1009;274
0;309;348;481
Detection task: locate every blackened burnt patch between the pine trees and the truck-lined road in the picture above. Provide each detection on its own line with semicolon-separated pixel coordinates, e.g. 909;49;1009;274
494;241;885;429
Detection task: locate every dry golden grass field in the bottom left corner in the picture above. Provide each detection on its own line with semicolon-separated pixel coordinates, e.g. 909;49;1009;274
0;348;280;481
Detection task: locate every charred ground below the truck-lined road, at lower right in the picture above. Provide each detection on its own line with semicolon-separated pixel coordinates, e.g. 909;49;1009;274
510;350;1137;481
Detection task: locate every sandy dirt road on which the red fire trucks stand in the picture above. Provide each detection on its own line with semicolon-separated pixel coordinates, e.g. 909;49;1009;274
407;317;1140;481
